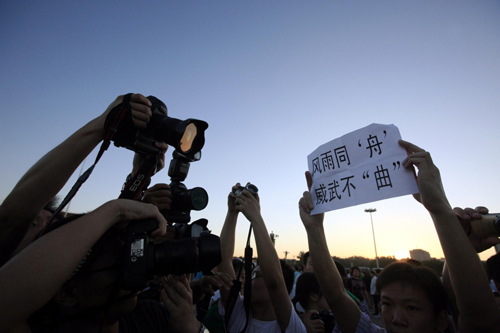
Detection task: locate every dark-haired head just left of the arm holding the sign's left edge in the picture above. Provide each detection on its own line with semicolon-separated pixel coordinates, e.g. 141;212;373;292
293;272;329;312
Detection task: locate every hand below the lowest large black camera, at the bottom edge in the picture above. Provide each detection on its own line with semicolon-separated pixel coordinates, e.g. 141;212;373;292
161;274;201;333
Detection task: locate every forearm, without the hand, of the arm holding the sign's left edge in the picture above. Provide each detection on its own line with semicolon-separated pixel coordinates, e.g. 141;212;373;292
306;224;361;333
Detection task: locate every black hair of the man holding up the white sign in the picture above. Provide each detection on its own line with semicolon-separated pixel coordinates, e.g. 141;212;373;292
376;261;448;316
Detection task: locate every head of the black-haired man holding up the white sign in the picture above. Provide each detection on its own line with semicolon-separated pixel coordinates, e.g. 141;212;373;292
376;262;448;333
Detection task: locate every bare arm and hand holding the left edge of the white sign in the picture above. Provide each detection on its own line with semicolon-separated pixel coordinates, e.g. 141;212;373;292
299;171;361;333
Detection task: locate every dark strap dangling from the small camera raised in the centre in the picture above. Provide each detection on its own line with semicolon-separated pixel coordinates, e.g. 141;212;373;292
224;224;253;333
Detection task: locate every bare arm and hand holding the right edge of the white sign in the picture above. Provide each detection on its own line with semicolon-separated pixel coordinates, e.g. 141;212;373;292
400;141;500;332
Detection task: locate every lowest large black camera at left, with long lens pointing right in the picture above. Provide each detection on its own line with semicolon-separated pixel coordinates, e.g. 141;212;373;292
121;219;222;290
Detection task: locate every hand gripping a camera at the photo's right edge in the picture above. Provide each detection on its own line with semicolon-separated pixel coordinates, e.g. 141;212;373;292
453;206;500;253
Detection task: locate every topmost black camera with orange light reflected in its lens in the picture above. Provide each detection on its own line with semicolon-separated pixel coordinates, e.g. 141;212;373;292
113;96;208;159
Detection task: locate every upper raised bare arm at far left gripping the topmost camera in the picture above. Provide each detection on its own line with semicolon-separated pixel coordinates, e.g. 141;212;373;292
0;94;151;266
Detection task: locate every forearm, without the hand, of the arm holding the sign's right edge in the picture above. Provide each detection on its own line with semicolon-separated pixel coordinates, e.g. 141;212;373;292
431;208;500;331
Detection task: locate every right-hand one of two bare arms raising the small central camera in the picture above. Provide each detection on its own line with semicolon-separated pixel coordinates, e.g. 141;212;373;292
236;190;293;332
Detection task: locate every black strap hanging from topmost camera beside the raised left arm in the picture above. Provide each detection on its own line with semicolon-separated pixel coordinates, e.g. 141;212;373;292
36;94;132;239
